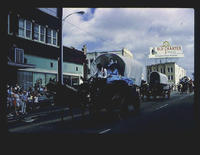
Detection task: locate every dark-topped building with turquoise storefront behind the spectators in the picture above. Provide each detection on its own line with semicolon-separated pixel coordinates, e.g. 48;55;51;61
8;8;85;89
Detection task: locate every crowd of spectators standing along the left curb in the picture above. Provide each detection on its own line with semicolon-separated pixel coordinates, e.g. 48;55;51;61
7;84;47;116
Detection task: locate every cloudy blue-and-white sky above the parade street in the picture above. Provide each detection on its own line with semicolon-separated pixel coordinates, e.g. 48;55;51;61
63;8;194;78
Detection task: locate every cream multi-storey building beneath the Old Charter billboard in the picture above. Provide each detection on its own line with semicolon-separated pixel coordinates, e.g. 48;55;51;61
147;62;186;85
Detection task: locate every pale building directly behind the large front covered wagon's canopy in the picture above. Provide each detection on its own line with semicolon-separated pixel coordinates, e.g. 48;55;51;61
86;48;133;78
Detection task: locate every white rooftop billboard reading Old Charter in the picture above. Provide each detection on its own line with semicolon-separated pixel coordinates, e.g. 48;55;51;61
149;41;184;58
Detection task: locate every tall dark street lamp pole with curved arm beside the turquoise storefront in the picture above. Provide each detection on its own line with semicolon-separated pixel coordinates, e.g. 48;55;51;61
58;8;85;85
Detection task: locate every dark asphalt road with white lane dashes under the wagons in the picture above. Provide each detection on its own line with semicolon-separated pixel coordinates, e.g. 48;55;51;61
9;92;196;135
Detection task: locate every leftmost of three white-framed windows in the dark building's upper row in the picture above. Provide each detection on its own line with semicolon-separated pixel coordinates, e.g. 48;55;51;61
18;18;32;39
